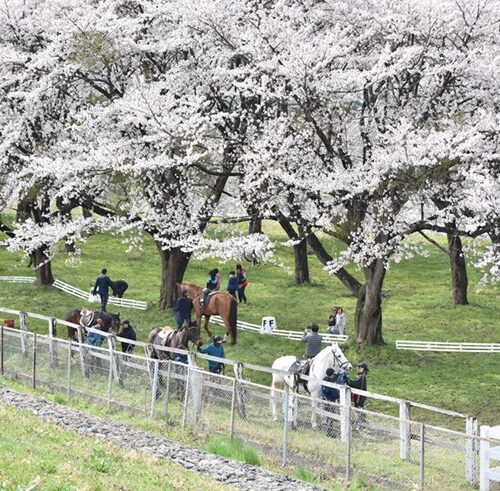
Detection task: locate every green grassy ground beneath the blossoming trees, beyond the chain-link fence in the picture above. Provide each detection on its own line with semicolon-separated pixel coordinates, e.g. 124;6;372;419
0;223;500;423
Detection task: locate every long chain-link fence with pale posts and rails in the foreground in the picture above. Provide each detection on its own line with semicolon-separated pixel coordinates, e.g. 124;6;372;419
0;327;488;490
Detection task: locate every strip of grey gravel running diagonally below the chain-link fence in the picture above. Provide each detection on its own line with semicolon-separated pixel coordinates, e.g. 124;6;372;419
0;389;319;491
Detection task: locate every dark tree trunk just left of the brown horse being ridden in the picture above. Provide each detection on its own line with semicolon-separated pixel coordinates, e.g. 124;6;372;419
157;244;191;310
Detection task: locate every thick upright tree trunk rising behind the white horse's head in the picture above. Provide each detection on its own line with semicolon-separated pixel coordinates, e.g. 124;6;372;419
354;260;385;348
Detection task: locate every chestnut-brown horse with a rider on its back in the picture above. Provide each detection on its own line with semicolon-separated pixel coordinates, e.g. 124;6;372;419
177;283;238;344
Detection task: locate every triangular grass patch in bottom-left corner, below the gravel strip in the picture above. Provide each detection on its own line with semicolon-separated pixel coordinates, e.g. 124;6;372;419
0;405;231;491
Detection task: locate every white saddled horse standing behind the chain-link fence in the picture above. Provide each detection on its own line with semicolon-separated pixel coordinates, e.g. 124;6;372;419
271;344;352;428
